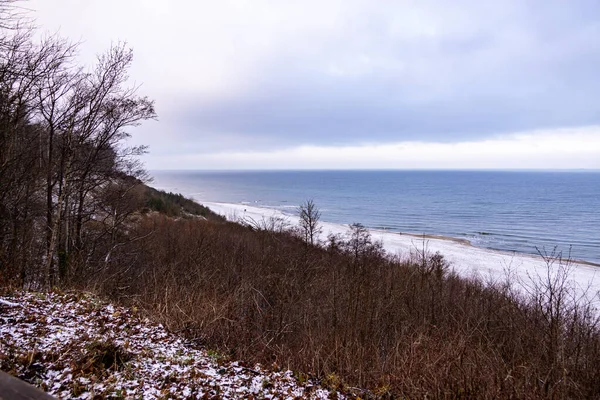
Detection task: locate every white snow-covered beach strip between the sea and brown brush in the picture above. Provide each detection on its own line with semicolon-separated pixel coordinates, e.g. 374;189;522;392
202;202;600;304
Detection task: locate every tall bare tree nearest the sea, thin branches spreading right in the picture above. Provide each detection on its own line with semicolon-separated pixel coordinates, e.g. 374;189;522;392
39;44;156;283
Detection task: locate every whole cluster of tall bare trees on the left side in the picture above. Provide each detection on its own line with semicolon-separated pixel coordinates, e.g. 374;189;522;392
0;0;155;287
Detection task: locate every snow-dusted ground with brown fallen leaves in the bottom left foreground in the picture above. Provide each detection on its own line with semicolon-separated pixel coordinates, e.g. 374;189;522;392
0;293;345;399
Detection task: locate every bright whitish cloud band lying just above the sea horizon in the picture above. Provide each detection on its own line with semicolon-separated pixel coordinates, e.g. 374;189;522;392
146;126;600;170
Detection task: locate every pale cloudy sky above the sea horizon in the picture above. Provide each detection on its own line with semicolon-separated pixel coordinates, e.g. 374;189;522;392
24;0;600;170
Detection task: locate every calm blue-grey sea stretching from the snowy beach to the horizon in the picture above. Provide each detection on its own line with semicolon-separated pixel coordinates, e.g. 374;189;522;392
152;171;600;263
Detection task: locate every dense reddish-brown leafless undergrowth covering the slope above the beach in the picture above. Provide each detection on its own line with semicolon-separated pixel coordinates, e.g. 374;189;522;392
70;215;600;398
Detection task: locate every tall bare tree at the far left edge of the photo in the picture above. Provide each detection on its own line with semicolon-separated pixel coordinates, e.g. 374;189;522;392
0;14;73;283
